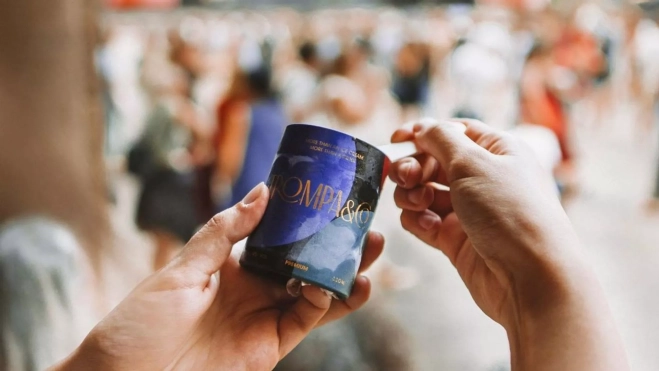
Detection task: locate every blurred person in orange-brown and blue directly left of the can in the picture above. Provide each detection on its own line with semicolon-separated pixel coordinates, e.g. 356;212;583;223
211;41;288;210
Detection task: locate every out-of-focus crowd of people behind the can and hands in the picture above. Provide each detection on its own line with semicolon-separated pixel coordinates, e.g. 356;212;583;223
97;3;659;268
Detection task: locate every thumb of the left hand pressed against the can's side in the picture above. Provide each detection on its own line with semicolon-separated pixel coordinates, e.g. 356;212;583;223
173;183;268;275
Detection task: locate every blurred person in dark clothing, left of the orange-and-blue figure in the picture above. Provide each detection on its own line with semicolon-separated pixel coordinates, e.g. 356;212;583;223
128;63;208;270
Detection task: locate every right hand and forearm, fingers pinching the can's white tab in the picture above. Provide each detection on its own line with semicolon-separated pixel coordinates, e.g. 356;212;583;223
391;120;627;370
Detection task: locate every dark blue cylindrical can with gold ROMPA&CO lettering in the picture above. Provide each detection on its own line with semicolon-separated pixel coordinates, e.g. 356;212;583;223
240;124;389;299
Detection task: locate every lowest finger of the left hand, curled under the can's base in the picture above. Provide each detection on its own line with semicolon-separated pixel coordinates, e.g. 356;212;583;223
278;286;332;358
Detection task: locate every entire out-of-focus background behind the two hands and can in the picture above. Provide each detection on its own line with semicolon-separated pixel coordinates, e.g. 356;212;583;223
0;0;659;371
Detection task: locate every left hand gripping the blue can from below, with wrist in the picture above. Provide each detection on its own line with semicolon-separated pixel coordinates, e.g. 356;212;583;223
57;184;384;370
